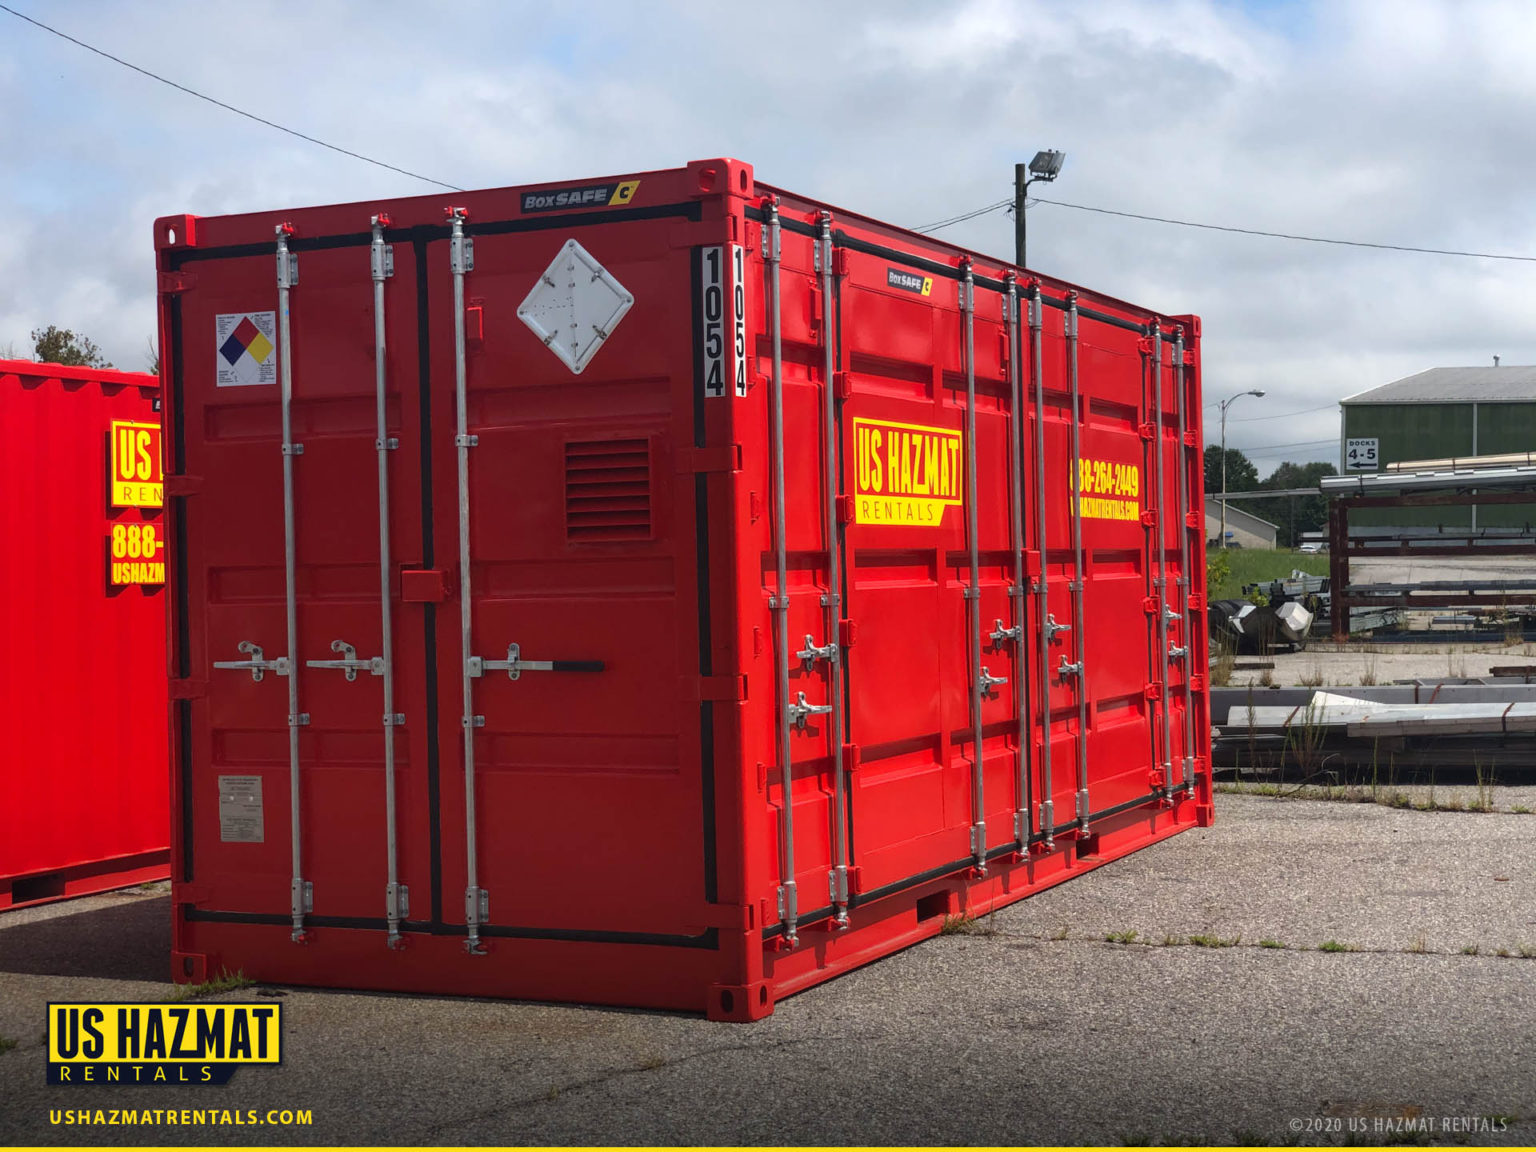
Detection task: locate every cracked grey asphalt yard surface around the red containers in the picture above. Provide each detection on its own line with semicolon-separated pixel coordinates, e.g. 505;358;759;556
0;794;1536;1144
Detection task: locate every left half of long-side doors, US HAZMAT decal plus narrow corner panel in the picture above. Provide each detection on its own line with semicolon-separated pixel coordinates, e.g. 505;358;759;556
780;265;1034;914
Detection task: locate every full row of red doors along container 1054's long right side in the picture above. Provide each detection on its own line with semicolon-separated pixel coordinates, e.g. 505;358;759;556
785;255;1195;909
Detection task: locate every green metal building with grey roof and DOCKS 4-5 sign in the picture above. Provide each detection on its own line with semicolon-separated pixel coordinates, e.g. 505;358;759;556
1339;364;1536;531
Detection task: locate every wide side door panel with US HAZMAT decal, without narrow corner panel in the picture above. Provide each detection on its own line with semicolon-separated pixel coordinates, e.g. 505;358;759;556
842;250;1021;891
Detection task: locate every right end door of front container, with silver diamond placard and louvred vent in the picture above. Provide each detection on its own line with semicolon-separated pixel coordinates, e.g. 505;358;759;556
425;220;714;948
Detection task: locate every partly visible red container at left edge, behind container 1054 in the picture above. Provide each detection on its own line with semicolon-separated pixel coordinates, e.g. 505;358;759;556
0;359;170;908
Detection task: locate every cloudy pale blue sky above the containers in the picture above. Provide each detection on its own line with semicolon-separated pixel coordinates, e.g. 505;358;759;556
0;0;1536;476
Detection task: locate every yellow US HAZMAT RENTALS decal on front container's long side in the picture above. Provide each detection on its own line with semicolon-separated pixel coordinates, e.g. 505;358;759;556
854;419;962;528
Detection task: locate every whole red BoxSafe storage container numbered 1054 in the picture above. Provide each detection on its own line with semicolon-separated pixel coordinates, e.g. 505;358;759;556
155;160;1212;1020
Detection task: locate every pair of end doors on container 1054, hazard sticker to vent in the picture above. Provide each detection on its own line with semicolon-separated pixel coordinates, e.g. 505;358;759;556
195;223;713;948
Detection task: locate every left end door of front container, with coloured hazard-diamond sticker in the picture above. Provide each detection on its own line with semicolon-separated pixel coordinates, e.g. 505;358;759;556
174;244;432;926
